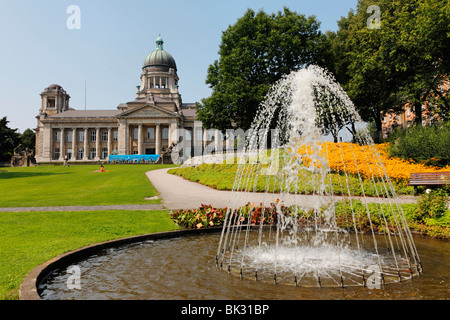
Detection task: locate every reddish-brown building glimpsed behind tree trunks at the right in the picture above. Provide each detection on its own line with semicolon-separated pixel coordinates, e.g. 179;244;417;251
382;79;449;138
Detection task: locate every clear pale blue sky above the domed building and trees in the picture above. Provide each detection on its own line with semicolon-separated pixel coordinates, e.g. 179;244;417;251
0;0;357;132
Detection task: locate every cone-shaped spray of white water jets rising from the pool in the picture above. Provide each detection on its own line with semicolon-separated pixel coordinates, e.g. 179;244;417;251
216;66;422;287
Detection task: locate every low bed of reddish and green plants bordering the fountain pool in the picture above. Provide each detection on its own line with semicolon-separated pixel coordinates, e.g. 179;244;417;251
171;201;450;239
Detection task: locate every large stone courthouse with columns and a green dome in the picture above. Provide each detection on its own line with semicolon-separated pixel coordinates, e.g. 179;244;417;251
35;37;202;163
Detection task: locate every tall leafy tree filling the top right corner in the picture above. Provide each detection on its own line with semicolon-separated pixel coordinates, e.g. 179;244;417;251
327;0;450;139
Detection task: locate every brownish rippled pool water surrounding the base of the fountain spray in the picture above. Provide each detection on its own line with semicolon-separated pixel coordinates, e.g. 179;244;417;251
41;234;450;300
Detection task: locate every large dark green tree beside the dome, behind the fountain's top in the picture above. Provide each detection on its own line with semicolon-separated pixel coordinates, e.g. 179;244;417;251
198;8;325;130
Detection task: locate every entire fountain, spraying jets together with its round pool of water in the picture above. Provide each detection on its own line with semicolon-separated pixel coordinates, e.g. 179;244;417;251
30;66;436;300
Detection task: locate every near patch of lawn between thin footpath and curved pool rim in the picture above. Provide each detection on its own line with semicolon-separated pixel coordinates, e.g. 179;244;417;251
0;210;178;300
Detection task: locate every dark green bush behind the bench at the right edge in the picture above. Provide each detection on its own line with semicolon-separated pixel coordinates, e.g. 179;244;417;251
389;122;450;167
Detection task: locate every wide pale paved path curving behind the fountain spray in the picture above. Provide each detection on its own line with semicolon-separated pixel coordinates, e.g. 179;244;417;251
147;169;416;210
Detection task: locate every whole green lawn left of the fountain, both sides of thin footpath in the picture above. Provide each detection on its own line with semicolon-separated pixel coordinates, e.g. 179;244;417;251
0;165;179;300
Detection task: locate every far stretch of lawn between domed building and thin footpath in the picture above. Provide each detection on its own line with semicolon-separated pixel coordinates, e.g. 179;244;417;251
0;165;177;207
